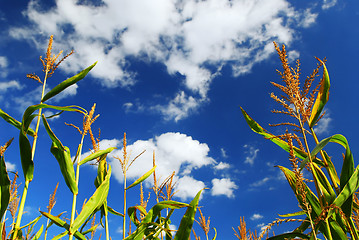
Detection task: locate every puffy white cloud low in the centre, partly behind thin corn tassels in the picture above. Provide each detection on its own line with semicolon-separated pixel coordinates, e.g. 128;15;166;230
83;132;215;200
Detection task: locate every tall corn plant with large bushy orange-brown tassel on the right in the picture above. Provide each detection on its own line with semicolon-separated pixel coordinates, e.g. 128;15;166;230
241;43;359;240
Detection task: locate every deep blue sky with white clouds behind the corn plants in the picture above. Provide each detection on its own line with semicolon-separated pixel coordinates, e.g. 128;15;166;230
0;0;359;239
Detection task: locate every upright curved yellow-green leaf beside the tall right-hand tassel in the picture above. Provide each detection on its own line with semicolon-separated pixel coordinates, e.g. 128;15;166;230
309;58;330;128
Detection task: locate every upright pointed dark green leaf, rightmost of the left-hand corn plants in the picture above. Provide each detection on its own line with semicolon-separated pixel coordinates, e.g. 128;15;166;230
174;190;202;240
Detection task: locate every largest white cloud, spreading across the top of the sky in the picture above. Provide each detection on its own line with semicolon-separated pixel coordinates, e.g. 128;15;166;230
9;0;320;121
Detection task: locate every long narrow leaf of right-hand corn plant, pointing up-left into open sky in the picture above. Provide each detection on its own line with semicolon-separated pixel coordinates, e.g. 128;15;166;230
241;107;307;159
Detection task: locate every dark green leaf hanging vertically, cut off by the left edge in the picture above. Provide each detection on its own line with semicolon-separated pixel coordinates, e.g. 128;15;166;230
0;153;10;220
